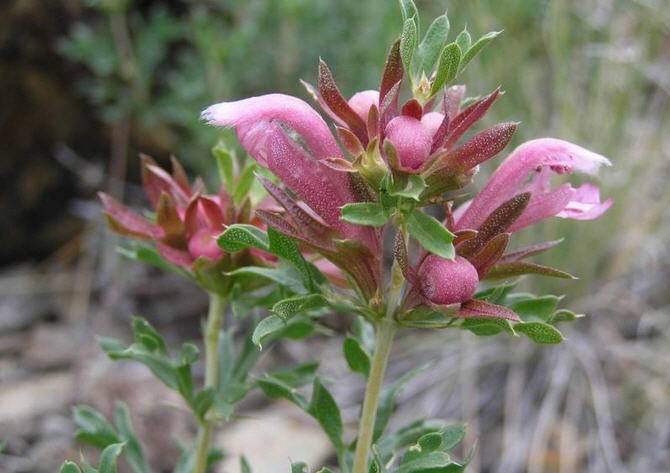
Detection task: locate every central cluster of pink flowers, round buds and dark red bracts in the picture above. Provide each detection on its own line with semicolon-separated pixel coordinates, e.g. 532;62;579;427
202;43;612;320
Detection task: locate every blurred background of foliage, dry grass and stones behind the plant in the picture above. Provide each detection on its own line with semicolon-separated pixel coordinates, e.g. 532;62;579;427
0;0;670;473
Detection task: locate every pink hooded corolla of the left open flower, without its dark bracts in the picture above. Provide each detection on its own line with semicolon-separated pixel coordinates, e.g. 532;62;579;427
202;94;377;248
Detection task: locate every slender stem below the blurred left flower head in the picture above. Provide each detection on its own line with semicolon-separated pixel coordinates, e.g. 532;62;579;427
193;292;226;473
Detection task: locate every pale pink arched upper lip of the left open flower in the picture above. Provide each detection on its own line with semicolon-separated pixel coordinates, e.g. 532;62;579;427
202;94;341;165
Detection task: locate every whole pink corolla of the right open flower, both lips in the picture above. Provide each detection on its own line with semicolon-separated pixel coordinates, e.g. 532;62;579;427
456;138;612;231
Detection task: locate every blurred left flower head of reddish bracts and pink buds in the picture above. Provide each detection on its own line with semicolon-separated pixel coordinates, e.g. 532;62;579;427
99;156;232;270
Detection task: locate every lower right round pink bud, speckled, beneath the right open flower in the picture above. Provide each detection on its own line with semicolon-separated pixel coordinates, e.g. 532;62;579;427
419;255;479;305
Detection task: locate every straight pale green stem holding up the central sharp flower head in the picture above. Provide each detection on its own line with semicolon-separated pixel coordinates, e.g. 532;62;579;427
352;317;396;473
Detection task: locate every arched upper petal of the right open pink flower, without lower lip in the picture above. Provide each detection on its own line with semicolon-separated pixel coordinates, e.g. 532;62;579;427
456;138;611;229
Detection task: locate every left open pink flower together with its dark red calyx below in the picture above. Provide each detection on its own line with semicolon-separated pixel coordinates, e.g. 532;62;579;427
202;94;381;296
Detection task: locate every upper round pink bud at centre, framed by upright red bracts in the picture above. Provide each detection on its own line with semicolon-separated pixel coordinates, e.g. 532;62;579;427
386;115;433;170
